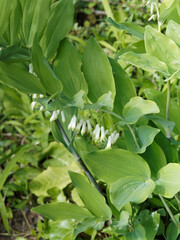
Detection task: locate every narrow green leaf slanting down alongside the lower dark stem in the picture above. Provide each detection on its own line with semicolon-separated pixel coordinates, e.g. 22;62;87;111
69;171;112;220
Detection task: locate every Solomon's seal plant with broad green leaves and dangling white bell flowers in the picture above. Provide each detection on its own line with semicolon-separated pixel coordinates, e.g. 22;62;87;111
0;0;180;240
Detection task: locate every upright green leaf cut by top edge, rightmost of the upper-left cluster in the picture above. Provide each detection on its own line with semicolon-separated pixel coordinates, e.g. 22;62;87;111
41;0;74;59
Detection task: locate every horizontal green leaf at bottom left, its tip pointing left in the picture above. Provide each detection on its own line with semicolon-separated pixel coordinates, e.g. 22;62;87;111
32;203;93;221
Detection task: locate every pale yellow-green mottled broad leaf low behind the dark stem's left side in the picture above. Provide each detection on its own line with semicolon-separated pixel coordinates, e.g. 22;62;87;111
29;162;79;196
